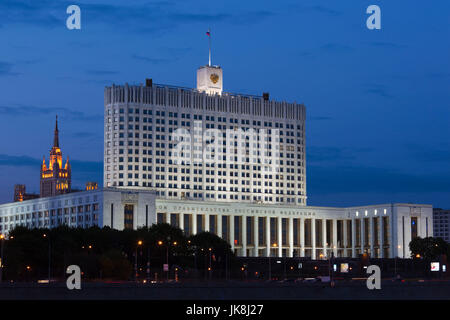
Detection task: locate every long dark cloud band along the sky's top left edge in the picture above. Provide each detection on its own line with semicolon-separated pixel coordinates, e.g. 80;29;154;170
0;0;273;33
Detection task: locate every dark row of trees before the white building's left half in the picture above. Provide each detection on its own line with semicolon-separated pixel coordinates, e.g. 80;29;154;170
3;224;236;281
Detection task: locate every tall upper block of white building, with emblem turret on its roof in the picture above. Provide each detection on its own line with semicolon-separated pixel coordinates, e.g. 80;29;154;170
104;66;306;206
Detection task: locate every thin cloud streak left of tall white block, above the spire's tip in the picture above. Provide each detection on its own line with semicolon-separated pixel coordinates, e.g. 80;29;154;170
0;105;103;121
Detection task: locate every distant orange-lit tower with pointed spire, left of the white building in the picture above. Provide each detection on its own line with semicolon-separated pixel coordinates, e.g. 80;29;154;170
40;116;72;197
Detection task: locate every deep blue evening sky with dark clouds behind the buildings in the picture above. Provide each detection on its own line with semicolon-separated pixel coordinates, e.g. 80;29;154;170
0;0;450;207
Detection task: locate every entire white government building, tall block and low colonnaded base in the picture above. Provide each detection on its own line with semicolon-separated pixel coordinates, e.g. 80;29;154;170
0;65;433;259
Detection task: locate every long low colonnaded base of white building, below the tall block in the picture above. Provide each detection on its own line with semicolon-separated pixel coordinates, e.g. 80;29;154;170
0;188;433;259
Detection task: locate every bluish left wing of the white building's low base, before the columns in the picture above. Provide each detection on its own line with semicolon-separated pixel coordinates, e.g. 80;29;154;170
0;188;155;234
